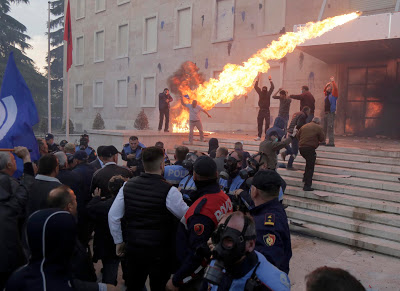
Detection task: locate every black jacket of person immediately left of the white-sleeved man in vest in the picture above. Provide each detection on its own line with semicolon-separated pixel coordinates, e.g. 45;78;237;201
87;196;118;262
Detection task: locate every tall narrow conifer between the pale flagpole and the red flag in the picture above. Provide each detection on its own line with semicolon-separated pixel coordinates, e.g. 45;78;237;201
45;0;64;123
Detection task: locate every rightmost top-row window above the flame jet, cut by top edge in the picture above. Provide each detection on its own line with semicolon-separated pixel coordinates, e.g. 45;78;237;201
258;0;286;35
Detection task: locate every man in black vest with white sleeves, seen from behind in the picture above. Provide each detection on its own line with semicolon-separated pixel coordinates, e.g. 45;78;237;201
108;147;188;290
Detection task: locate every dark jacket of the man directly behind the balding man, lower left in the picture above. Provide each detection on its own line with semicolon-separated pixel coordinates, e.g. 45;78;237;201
27;176;61;217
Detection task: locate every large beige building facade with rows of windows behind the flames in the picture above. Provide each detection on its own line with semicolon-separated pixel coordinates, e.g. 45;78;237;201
64;0;400;135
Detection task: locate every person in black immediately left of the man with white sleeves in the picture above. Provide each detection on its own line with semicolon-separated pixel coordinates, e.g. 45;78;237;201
87;176;128;286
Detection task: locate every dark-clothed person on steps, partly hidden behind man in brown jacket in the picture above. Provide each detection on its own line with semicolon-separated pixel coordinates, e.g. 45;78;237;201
281;106;311;171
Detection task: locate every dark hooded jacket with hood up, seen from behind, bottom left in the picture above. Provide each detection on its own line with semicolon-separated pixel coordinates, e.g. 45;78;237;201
6;209;76;291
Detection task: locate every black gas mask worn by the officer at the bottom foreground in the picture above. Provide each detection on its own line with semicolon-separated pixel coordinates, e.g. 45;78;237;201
204;215;256;285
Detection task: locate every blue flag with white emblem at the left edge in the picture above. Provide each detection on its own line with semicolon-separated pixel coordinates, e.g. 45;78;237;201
0;52;40;177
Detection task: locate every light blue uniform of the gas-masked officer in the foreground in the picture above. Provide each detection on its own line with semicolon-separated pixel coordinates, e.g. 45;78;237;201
208;251;290;291
